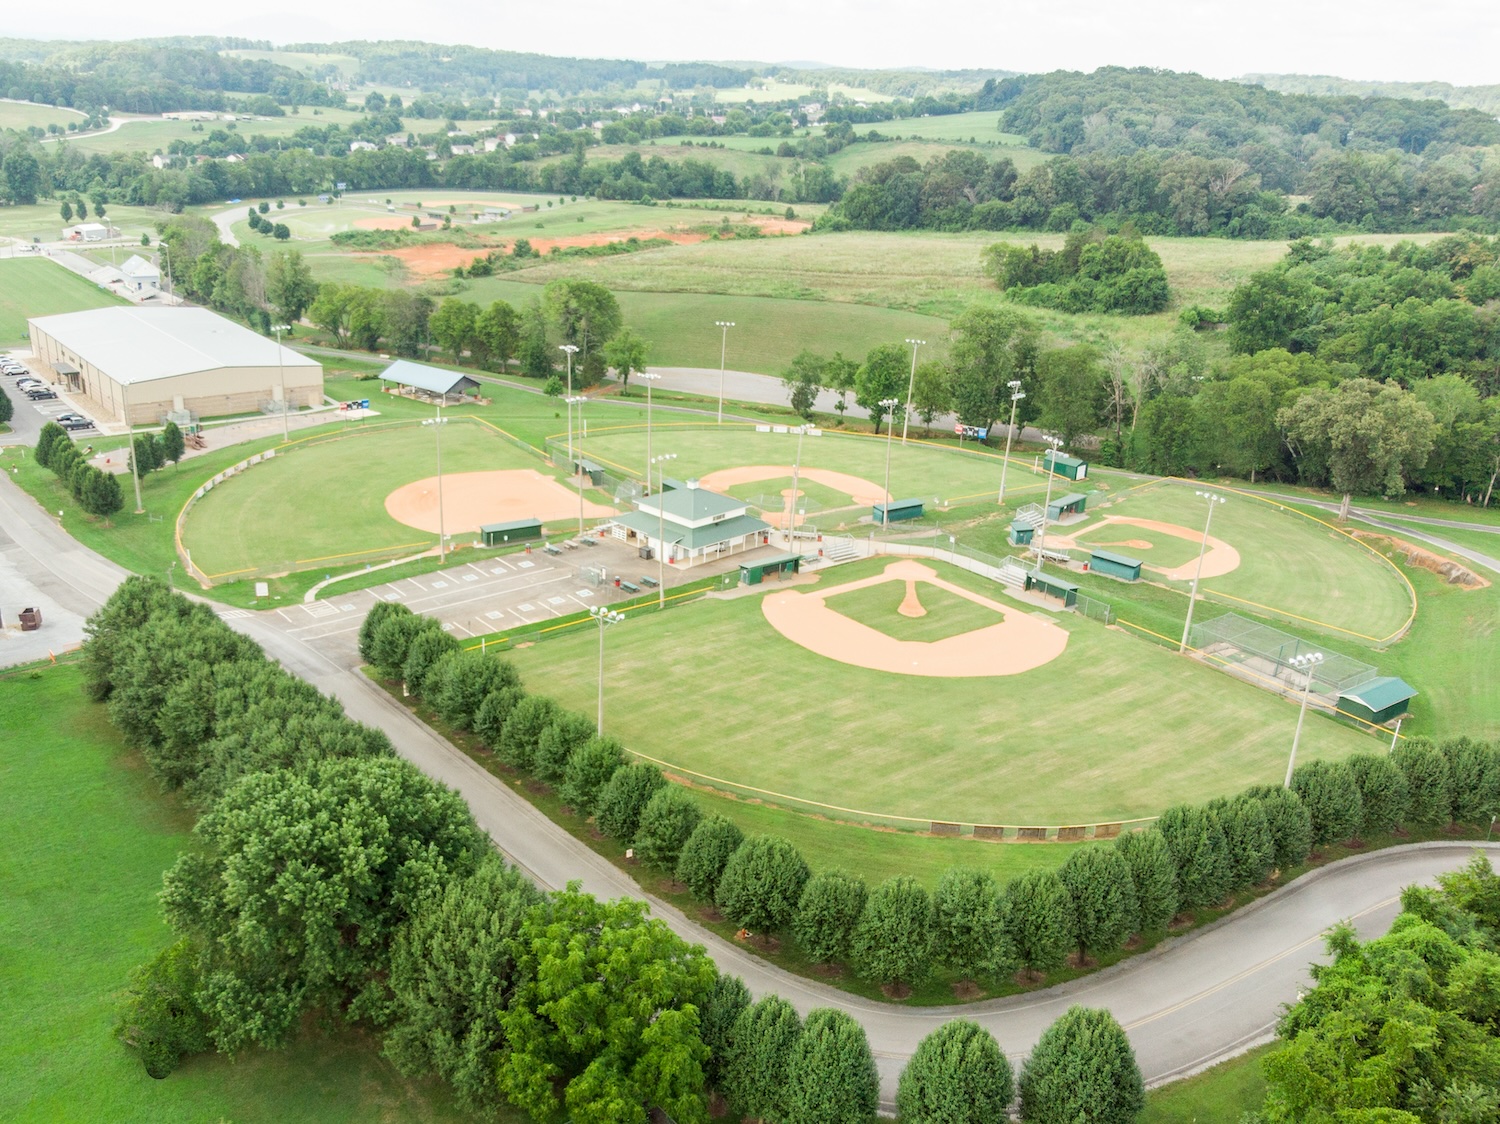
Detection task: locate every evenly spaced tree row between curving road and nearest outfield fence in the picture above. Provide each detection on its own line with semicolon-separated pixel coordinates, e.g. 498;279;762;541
369;603;1500;990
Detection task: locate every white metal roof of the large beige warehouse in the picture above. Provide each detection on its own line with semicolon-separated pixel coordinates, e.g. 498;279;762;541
30;308;323;386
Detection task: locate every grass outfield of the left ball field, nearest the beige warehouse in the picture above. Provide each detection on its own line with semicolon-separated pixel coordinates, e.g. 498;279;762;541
183;423;558;578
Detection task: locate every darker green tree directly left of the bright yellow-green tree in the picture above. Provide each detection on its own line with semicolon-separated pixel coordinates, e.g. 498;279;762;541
384;854;542;1112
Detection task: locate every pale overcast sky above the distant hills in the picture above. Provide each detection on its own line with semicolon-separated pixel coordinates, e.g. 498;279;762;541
11;0;1500;86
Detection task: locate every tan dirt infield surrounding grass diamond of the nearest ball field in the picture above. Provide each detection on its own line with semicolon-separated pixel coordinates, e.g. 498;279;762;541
758;558;1068;678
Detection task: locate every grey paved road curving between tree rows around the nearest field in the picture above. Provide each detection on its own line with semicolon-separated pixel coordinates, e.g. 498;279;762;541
0;468;1500;1109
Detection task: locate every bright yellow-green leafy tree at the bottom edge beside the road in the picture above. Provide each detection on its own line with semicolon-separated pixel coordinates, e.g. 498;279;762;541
497;882;716;1124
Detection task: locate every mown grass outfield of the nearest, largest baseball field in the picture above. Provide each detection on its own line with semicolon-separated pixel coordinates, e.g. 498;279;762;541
512;560;1374;824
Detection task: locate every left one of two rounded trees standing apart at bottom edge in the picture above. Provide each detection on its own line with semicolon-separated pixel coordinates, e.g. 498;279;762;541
896;1019;1016;1124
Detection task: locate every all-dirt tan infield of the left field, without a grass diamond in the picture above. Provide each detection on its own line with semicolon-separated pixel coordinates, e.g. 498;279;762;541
386;468;615;534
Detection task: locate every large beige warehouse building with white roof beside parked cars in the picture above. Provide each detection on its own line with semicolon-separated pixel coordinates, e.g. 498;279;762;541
29;308;323;425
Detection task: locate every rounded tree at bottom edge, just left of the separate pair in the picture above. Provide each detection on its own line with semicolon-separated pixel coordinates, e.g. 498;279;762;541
786;1007;881;1124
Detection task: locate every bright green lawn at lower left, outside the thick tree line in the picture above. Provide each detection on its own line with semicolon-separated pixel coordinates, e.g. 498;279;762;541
0;665;468;1124
